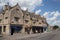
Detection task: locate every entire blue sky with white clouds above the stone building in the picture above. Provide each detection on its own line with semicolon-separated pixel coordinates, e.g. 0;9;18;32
0;0;60;26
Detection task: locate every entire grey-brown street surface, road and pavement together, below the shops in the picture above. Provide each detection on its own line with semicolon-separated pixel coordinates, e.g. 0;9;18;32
2;30;60;40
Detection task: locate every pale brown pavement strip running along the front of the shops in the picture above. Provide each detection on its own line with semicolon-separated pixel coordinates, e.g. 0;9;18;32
2;32;50;40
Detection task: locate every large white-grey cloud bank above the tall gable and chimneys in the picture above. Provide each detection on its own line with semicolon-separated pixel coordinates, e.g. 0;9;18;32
2;0;43;11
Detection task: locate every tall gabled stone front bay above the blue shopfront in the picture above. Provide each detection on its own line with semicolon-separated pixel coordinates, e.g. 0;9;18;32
10;4;23;24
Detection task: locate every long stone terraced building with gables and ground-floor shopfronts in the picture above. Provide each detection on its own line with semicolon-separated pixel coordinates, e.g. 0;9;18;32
0;4;48;35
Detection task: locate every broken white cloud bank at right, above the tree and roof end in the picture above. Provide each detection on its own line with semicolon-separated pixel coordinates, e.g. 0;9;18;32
43;11;60;26
